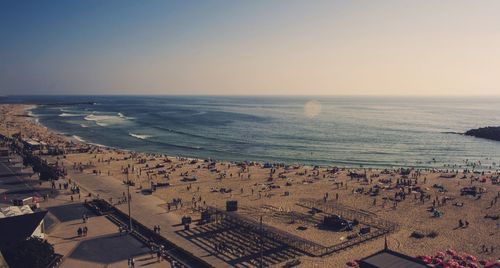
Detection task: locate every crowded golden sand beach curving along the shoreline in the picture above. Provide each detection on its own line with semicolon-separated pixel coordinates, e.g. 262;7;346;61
0;104;500;267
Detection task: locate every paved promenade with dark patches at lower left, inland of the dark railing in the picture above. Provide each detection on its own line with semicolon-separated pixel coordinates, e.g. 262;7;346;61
0;155;171;268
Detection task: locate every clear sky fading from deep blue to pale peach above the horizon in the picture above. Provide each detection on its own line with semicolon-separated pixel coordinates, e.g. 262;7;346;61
0;0;500;96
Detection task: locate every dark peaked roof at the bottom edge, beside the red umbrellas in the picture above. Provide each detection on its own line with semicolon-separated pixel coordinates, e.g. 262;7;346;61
359;249;427;268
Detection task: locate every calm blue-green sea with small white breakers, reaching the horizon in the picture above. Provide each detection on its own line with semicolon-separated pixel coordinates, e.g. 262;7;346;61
0;96;500;167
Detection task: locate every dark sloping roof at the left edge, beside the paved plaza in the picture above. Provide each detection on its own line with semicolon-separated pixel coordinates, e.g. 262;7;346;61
0;211;47;250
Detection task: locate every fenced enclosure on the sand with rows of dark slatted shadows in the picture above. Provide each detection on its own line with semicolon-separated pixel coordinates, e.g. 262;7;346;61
179;199;396;267
